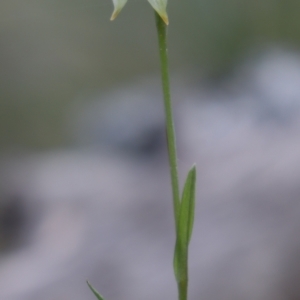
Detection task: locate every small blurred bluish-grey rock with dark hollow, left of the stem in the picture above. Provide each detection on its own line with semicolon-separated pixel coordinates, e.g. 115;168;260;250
68;79;165;158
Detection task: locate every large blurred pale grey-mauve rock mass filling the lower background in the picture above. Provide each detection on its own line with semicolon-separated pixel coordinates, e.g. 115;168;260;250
0;50;300;300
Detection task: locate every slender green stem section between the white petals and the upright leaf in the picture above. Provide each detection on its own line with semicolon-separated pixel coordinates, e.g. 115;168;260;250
155;12;180;233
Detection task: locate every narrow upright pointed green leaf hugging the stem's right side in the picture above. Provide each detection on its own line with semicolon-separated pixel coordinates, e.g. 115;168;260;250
178;166;196;247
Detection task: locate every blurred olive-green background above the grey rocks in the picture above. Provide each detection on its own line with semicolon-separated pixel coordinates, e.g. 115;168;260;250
0;0;300;152
